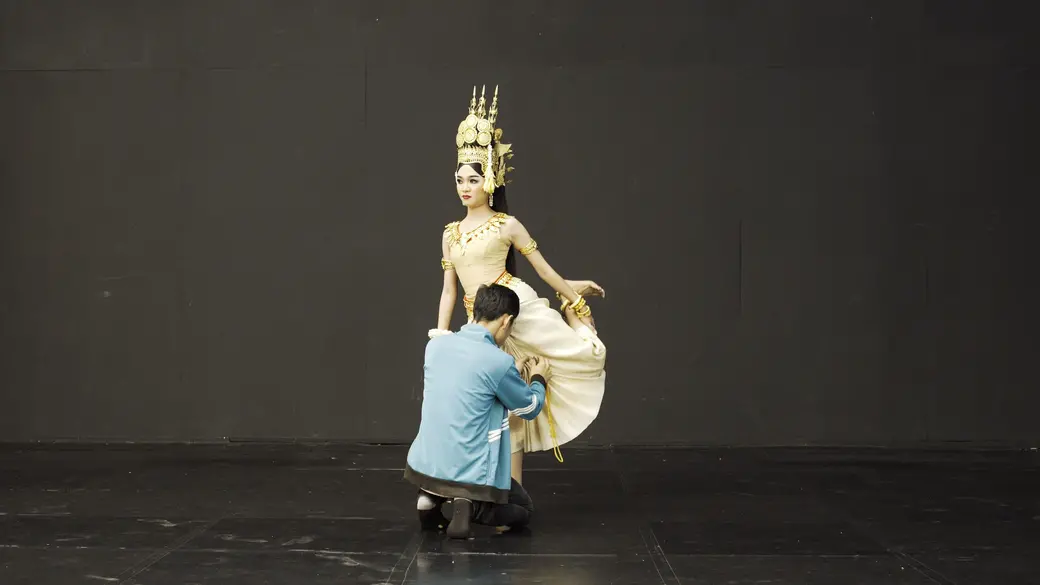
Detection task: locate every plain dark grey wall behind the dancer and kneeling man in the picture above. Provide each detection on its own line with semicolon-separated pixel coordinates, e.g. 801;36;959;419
0;0;1040;444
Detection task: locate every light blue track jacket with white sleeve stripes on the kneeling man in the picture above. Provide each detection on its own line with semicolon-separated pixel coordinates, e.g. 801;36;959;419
405;324;546;503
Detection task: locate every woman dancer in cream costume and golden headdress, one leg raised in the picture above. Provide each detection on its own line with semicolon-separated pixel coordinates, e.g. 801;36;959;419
430;87;606;483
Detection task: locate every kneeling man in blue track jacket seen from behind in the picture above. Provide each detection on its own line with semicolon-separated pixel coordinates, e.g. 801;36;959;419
405;284;549;538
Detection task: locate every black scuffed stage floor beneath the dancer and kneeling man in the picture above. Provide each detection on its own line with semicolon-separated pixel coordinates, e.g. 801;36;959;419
0;444;1040;585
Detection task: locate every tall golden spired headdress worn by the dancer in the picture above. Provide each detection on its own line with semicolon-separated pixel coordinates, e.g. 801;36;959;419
456;85;513;195
